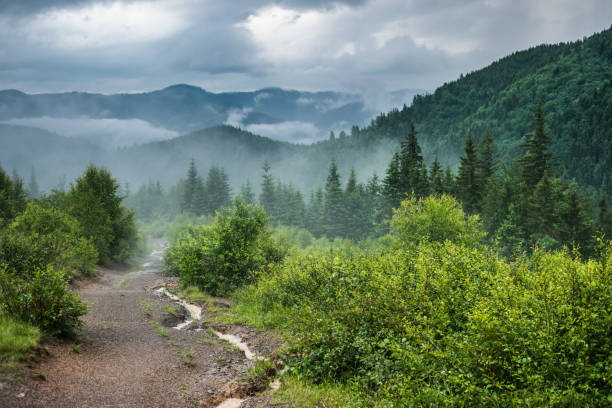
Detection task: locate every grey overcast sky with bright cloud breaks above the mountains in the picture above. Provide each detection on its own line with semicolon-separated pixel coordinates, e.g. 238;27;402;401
0;0;612;93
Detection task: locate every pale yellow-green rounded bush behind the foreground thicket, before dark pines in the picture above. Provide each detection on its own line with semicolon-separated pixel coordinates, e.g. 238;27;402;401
391;194;484;247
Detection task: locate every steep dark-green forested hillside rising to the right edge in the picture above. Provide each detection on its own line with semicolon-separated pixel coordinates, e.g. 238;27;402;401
330;29;612;192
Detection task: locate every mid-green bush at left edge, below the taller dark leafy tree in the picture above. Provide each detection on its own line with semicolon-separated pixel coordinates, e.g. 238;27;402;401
0;203;98;275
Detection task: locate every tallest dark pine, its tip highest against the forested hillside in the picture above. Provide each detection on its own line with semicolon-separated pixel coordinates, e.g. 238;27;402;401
519;103;552;190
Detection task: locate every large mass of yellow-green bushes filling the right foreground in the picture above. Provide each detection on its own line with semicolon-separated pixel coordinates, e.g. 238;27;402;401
237;212;612;406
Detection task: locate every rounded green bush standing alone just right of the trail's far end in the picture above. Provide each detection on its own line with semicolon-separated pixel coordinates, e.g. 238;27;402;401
164;199;284;295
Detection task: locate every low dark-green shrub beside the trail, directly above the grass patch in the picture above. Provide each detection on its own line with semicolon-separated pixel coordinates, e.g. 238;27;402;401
0;265;87;335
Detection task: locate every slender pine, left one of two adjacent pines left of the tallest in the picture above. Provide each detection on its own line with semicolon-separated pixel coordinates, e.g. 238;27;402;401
457;131;482;213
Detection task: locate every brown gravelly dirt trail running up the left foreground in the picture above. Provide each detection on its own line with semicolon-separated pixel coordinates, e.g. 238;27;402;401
0;245;274;408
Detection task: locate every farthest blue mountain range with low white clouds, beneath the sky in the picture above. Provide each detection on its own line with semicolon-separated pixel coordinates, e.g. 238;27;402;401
0;84;416;146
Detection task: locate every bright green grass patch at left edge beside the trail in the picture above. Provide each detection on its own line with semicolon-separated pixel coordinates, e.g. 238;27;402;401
0;314;41;362
